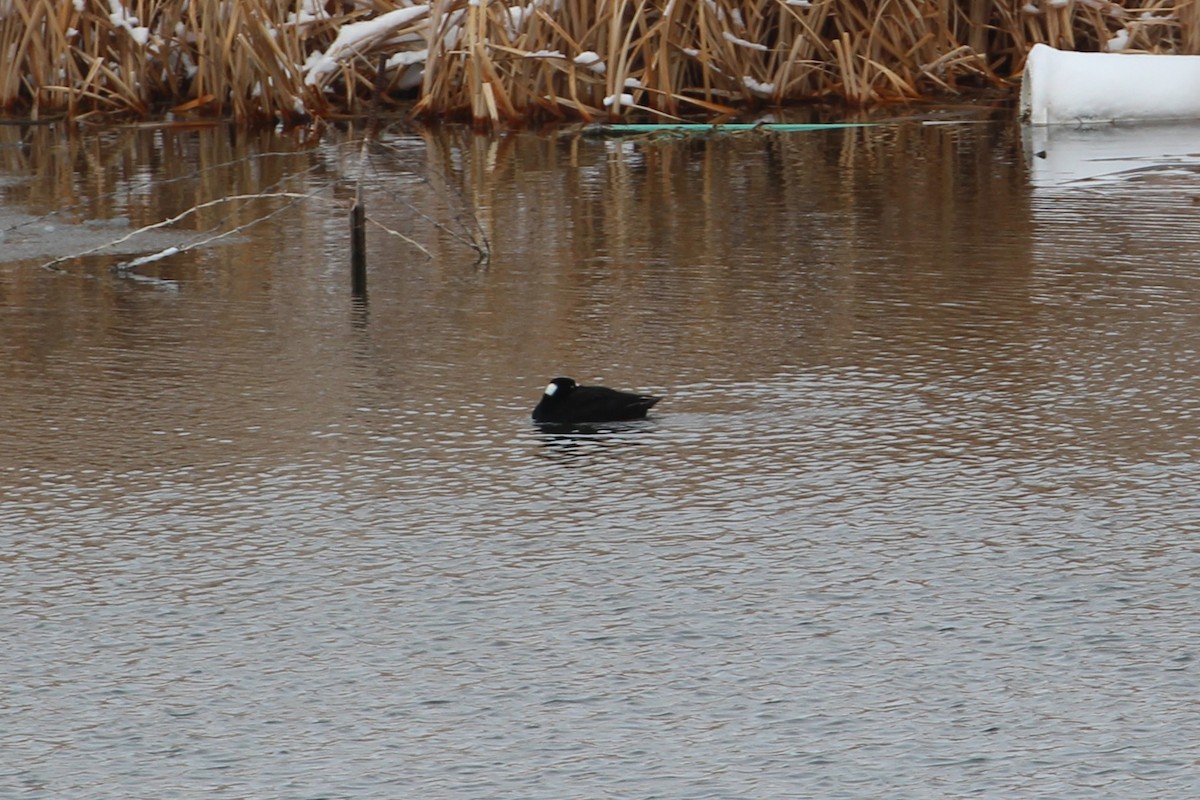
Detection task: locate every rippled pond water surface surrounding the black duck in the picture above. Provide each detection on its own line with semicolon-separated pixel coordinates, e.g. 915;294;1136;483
0;115;1200;799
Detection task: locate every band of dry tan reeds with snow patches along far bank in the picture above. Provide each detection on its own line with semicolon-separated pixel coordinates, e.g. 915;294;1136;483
0;0;1200;124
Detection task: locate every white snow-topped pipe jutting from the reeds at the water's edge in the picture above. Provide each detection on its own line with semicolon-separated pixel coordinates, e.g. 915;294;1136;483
1020;44;1200;125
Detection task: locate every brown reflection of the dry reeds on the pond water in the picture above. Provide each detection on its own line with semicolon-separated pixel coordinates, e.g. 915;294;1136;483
2;118;1038;479
